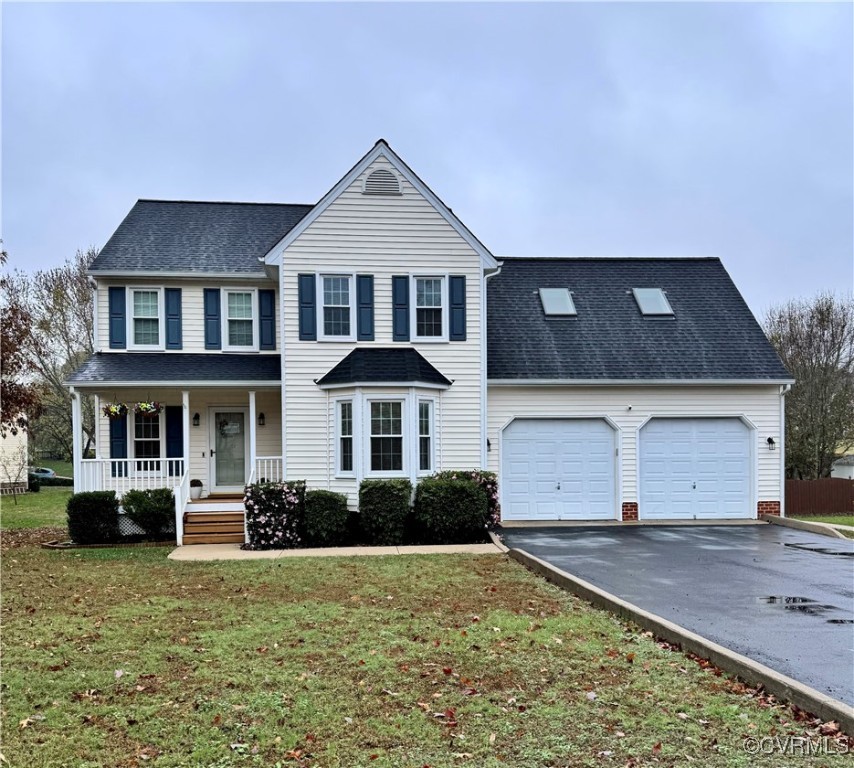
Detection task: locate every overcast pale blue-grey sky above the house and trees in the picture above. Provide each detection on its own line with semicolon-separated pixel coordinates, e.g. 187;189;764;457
2;2;854;314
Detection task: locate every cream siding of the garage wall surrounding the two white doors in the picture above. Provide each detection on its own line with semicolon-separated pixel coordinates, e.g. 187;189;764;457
487;384;782;508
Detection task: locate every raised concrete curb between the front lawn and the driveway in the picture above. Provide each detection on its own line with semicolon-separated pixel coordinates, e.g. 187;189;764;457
510;549;854;736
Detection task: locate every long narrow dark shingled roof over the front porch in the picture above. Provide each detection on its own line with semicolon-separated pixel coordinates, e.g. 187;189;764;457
67;352;282;386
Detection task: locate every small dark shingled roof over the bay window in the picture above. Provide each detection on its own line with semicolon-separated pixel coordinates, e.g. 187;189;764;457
317;347;451;387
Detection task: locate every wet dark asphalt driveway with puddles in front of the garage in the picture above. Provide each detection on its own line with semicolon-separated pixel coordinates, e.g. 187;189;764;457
502;525;854;705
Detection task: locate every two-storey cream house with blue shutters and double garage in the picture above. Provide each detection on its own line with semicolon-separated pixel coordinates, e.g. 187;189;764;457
68;141;791;541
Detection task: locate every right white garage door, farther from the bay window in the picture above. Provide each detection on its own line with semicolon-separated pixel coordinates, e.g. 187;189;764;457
638;419;754;520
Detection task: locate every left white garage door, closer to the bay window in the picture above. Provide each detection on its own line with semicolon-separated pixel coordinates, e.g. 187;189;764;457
501;419;616;520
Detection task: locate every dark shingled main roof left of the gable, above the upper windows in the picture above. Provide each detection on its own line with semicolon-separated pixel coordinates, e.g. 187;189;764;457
90;200;314;275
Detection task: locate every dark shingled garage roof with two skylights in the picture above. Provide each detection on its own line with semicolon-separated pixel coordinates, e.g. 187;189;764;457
487;258;791;380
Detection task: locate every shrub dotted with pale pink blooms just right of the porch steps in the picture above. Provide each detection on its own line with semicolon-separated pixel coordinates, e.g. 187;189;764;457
243;480;305;549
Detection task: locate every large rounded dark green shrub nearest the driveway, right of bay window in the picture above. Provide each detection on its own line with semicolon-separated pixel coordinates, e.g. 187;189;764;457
413;477;489;544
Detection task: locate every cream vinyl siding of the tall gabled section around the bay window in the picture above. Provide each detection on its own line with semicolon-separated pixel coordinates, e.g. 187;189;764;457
282;159;485;506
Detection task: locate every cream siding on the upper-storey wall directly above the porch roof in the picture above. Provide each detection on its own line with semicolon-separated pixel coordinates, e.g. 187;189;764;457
95;277;282;354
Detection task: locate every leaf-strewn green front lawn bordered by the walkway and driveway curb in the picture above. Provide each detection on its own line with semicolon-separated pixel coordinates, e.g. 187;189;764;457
2;548;841;768
